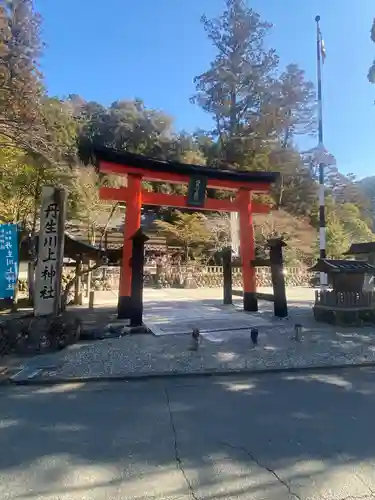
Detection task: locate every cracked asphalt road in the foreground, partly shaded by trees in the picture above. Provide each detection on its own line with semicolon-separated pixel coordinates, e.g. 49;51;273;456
0;370;375;500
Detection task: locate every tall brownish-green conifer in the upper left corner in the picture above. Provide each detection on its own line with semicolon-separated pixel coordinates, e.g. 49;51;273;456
0;0;47;153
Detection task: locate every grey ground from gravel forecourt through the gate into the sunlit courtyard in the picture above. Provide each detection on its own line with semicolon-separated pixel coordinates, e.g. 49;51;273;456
4;289;375;382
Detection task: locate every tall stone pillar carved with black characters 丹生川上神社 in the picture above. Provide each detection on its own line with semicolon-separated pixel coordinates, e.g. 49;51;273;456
34;186;65;316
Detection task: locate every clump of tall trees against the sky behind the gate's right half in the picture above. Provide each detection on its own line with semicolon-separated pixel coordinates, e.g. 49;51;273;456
192;0;316;174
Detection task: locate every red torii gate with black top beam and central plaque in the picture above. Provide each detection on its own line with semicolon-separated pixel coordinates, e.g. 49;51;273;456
94;148;278;318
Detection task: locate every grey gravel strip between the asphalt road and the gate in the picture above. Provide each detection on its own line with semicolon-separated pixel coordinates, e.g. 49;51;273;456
9;325;375;381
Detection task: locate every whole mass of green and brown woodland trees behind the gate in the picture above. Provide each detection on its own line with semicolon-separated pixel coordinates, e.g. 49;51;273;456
0;0;373;264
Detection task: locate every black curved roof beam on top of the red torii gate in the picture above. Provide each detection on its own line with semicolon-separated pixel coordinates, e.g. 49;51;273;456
93;147;279;184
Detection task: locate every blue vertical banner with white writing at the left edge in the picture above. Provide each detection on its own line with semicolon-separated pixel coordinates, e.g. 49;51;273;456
0;224;18;299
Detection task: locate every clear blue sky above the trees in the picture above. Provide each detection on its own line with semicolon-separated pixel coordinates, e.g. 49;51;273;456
35;0;375;177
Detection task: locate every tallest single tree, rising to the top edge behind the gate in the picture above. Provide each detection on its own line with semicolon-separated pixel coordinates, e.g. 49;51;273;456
192;0;278;167
